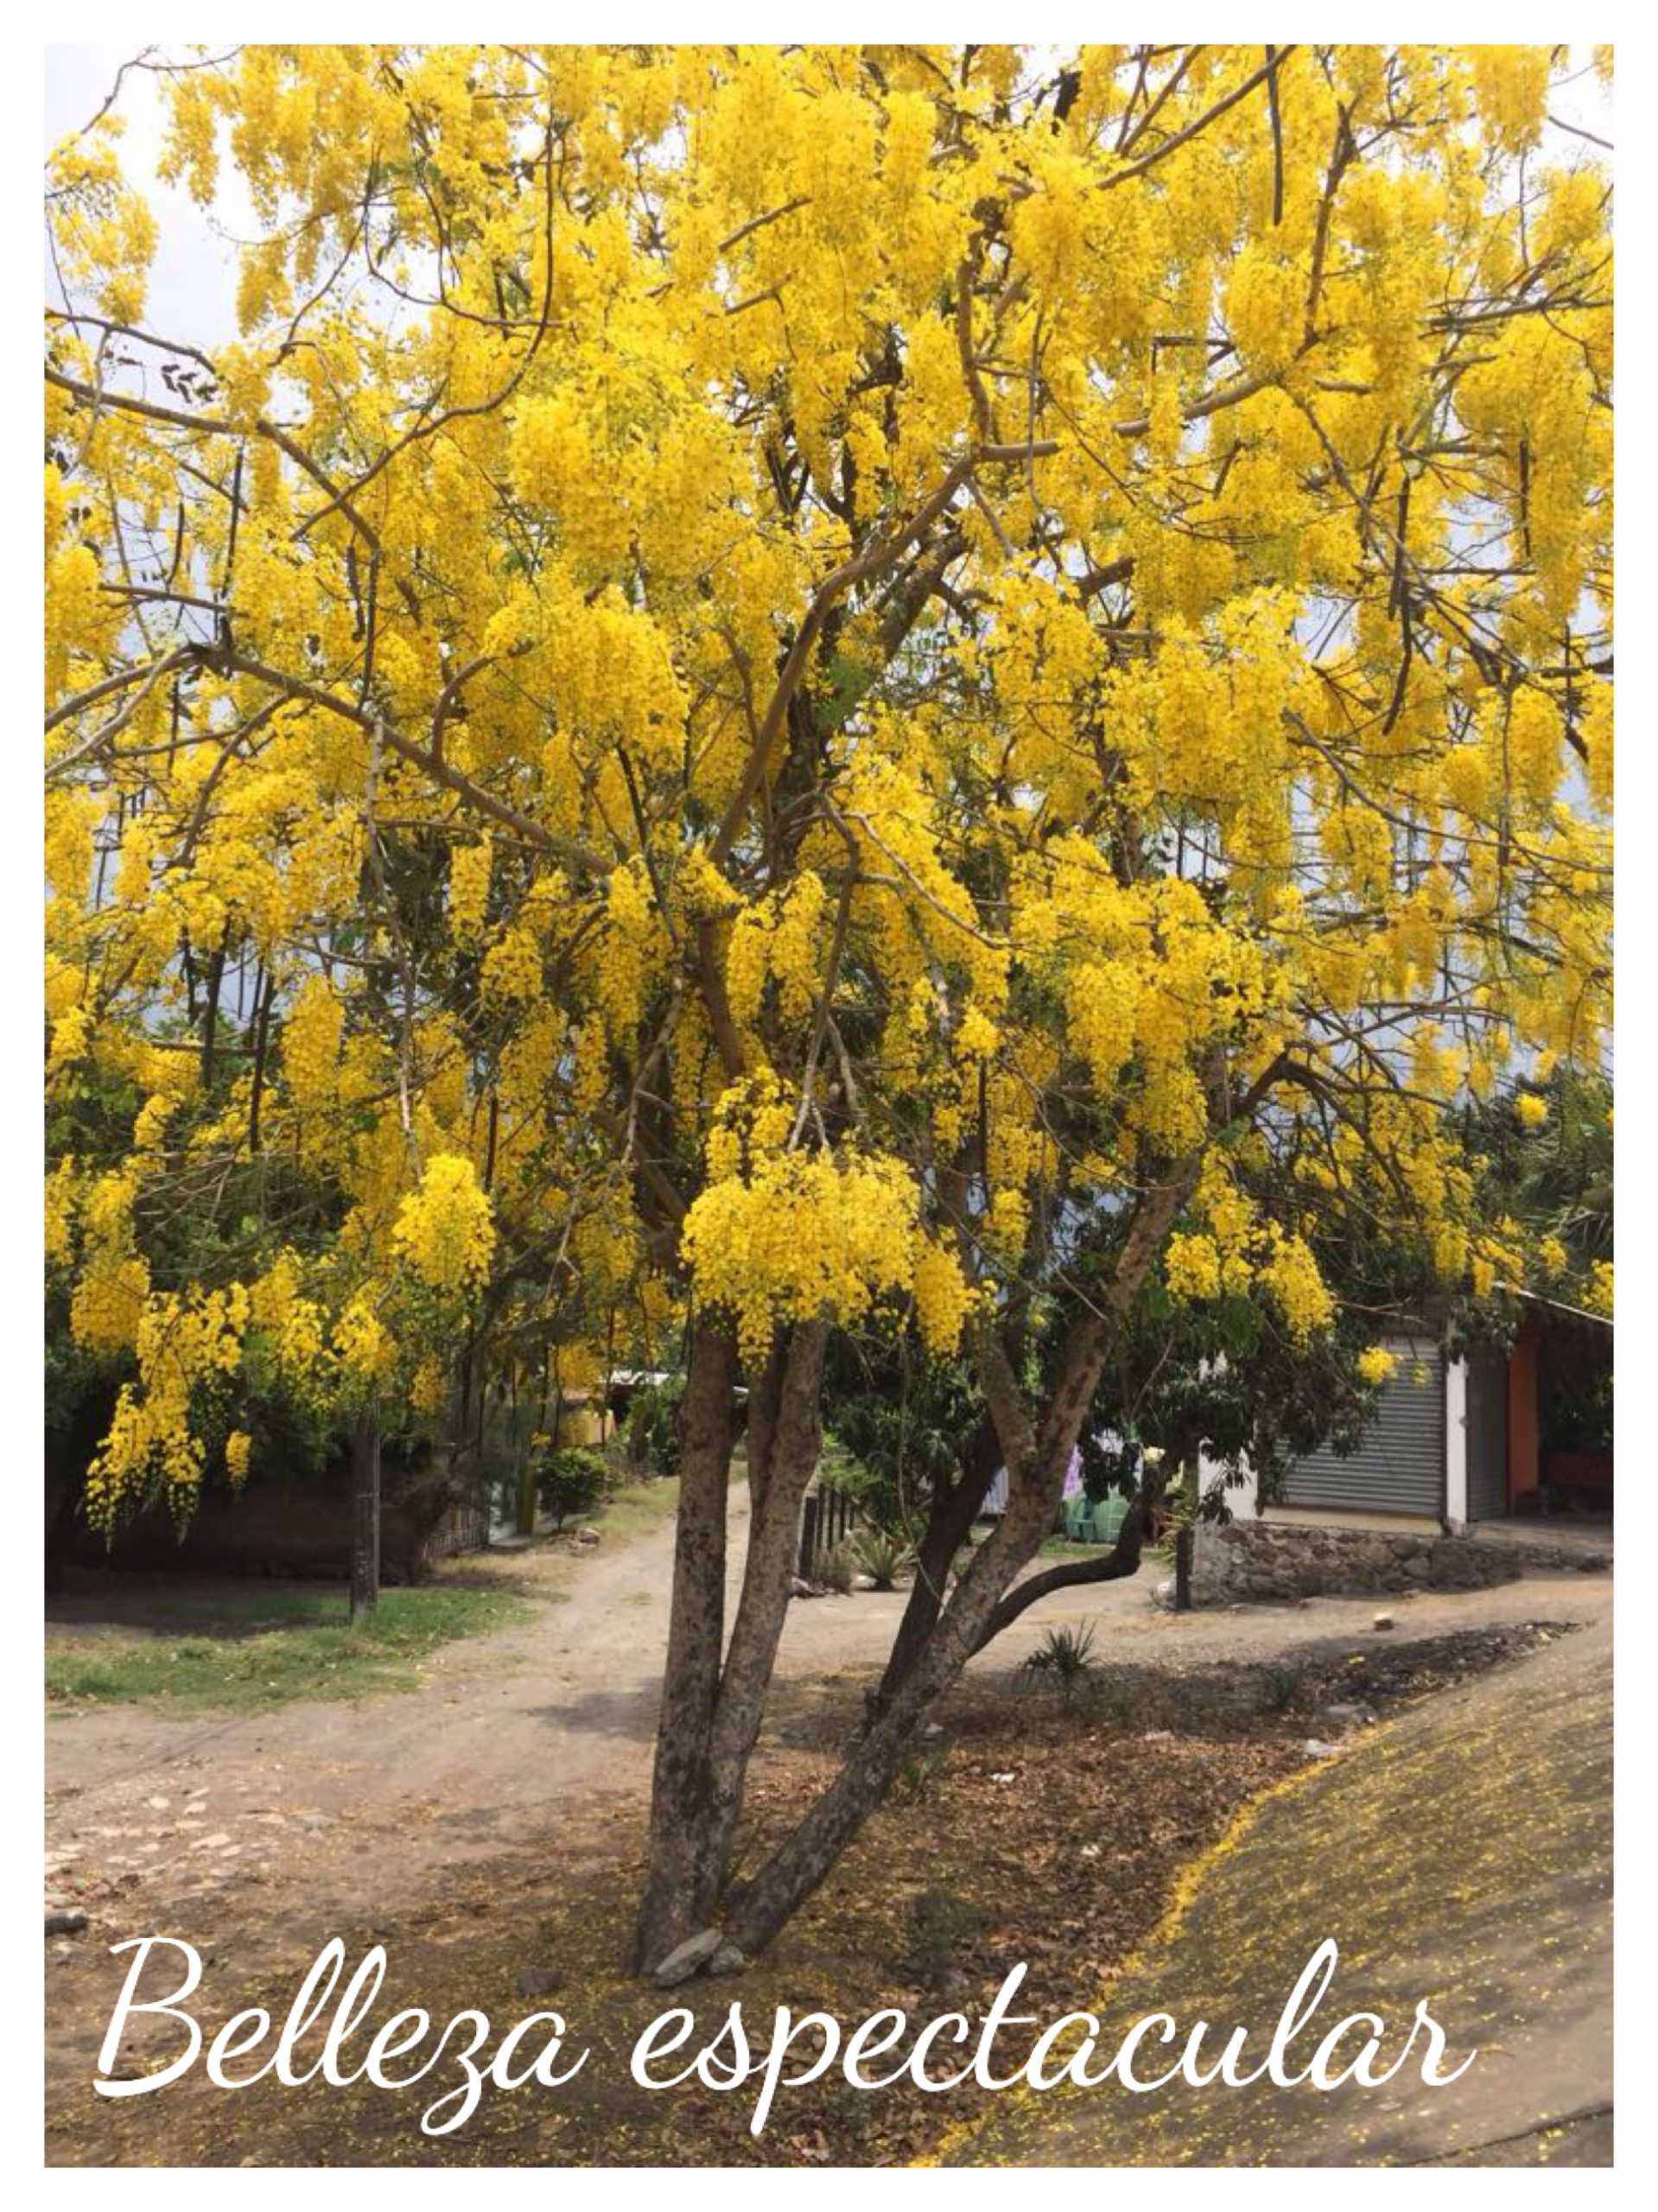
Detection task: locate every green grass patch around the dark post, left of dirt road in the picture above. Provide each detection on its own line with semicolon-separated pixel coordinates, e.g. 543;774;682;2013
47;1588;530;1710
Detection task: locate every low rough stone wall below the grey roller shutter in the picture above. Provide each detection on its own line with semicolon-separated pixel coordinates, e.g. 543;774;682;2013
1191;1520;1605;1606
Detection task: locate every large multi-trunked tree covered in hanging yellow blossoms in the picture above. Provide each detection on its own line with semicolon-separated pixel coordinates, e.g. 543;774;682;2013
47;47;1611;1964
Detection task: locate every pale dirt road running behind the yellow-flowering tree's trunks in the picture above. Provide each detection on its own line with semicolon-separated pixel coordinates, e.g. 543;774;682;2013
47;1486;1610;1913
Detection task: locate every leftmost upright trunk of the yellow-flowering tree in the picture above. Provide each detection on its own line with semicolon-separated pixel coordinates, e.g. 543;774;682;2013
632;1314;736;1971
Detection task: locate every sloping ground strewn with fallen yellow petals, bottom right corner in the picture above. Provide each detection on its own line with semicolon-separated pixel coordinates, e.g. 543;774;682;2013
953;1584;1611;2165
